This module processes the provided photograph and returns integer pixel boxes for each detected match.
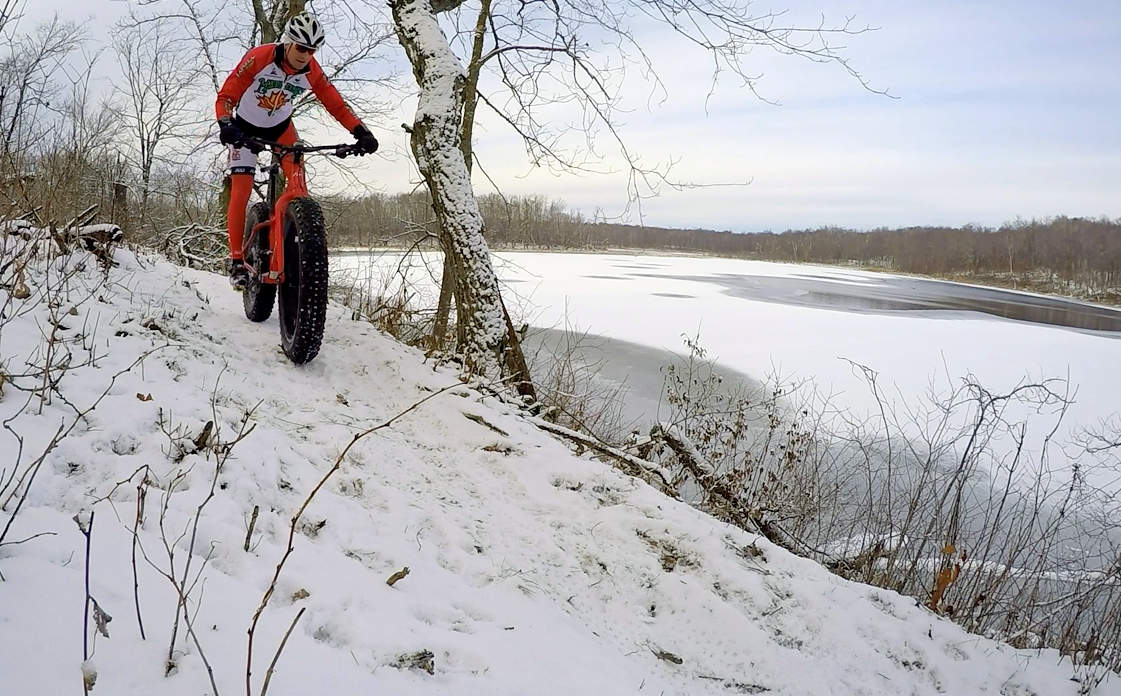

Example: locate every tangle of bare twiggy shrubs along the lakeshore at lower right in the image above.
[643,333,1121,684]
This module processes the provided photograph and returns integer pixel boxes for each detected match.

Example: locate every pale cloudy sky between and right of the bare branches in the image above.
[17,0,1121,231]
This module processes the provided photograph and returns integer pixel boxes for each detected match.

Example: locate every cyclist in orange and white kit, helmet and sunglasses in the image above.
[214,12,378,290]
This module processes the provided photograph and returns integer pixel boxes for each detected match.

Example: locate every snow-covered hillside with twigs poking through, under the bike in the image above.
[0,242,1103,696]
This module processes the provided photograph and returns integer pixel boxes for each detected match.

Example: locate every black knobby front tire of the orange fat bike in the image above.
[279,198,327,365]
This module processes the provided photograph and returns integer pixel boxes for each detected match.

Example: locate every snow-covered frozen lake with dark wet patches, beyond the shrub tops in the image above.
[333,252,1121,450]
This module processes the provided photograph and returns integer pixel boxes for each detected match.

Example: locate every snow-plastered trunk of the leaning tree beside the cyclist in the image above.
[390,0,506,377]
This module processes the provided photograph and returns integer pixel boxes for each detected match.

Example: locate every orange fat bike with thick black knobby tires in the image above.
[241,138,367,364]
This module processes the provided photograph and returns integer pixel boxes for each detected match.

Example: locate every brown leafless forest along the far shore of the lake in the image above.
[327,195,1121,304]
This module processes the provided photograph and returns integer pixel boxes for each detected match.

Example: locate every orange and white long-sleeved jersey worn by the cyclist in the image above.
[214,44,362,140]
